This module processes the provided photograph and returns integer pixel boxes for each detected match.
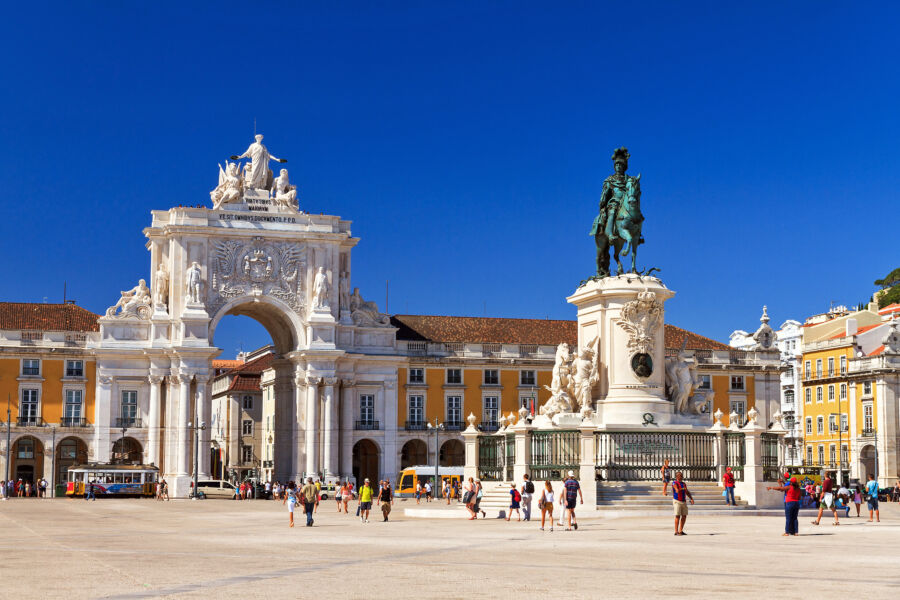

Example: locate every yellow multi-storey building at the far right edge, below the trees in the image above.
[800,309,900,485]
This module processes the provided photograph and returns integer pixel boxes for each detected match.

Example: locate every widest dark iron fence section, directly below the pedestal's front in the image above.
[594,432,717,481]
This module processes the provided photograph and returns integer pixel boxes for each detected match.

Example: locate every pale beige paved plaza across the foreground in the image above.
[0,499,900,600]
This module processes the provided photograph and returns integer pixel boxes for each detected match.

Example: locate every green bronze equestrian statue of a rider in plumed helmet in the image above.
[590,147,644,277]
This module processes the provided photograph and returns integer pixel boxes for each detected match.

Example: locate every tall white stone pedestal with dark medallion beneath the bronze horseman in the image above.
[567,274,681,427]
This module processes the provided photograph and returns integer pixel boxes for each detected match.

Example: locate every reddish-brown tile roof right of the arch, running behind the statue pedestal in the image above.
[391,315,733,350]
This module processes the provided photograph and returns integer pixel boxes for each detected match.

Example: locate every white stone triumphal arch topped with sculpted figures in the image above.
[92,135,400,496]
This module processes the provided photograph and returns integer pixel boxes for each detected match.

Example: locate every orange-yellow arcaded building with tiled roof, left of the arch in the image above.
[0,302,99,494]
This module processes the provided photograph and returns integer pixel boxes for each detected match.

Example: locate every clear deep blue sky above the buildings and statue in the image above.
[0,2,900,355]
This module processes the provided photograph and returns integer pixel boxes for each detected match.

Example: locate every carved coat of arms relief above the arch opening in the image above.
[210,237,306,314]
